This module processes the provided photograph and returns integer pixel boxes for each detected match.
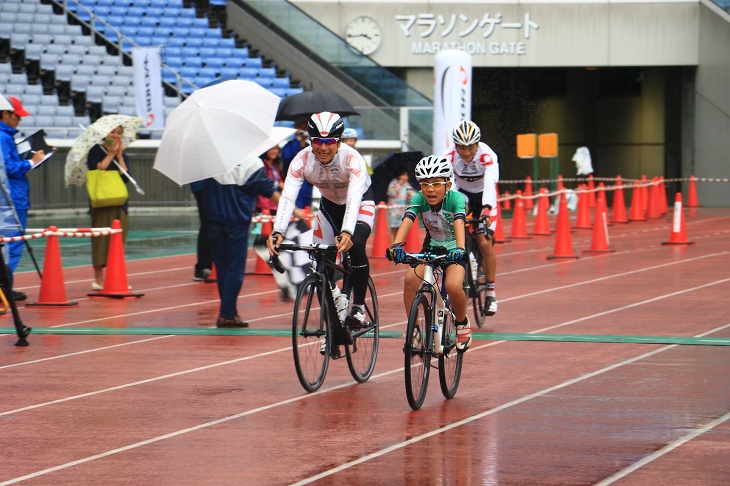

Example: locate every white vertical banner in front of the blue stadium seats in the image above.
[132,47,165,128]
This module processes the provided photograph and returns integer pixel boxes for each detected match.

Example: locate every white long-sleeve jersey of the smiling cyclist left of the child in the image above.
[274,143,370,234]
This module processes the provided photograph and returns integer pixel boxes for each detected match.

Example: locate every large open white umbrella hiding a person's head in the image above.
[153,80,293,185]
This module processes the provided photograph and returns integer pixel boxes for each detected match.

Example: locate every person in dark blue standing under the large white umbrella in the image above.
[203,155,279,327]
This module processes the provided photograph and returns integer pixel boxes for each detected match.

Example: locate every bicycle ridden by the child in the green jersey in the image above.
[392,253,463,410]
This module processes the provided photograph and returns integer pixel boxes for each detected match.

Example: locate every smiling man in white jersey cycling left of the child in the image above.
[267,111,375,323]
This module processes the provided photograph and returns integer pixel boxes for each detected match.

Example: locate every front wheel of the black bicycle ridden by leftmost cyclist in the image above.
[292,274,331,393]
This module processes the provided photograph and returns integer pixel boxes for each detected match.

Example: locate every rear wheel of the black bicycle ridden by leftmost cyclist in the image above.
[345,278,380,383]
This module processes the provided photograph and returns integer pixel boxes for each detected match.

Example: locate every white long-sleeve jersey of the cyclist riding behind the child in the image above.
[444,142,499,208]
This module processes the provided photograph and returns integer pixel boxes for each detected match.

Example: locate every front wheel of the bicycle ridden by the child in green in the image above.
[403,293,433,410]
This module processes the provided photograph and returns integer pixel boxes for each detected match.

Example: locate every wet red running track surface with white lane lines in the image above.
[0,209,730,485]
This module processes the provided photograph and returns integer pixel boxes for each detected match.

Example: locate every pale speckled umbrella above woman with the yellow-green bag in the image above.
[65,115,144,187]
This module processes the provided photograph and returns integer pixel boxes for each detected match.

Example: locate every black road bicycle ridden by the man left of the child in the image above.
[272,243,380,393]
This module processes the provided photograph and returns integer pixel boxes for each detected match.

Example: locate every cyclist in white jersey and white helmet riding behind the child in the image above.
[444,120,501,316]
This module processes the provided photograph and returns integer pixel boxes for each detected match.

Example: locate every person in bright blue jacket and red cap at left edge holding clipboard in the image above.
[0,96,45,300]
